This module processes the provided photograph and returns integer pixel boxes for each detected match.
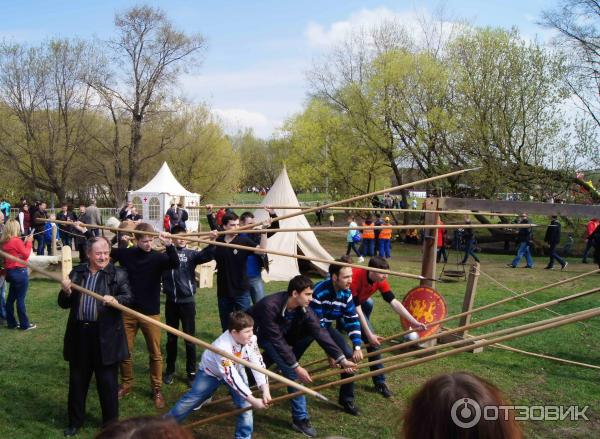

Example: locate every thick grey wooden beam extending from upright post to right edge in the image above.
[438,198,600,218]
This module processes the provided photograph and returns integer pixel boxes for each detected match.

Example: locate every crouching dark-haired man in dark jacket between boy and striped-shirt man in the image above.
[249,275,356,437]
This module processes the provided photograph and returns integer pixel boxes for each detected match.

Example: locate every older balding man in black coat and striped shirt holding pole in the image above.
[58,237,132,436]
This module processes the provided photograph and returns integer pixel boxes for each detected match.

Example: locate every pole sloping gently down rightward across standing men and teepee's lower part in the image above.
[39,219,425,280]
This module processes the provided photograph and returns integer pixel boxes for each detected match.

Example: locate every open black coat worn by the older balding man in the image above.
[58,264,133,365]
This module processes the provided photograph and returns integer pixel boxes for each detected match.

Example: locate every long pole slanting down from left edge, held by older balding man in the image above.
[0,250,327,401]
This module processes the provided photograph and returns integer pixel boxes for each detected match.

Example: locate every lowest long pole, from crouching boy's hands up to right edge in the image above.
[185,308,600,428]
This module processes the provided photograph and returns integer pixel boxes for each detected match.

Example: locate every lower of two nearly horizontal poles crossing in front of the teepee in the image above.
[190,224,540,237]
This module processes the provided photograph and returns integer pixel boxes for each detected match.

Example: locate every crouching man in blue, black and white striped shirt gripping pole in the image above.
[299,261,363,416]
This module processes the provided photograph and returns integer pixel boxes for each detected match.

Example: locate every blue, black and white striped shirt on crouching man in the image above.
[310,279,362,346]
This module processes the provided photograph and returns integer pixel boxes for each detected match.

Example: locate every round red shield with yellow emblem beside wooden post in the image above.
[400,287,448,338]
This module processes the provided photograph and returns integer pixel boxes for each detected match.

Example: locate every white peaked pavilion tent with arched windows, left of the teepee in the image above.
[127,162,200,230]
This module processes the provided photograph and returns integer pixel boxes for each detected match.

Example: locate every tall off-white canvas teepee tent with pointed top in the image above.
[254,168,333,281]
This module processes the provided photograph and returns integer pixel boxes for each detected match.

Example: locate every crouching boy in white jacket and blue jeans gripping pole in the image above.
[165,311,271,439]
